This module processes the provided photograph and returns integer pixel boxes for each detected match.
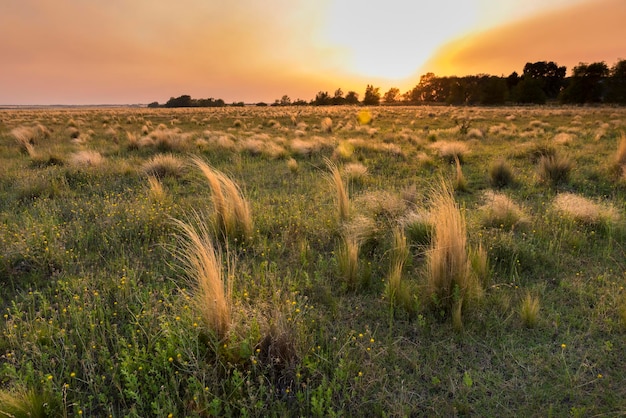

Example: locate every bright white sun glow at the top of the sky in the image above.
[326,0,478,80]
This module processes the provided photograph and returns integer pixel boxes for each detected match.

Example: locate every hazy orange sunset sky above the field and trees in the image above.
[0,0,626,105]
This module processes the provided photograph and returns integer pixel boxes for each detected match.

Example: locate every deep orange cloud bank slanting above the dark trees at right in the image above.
[422,0,626,76]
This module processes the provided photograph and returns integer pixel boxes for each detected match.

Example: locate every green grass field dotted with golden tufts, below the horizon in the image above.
[0,107,626,417]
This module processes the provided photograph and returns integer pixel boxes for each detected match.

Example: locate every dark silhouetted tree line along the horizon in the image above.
[148,60,626,107]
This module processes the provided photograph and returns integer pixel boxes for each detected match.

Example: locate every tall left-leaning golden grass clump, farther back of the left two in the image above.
[191,157,252,240]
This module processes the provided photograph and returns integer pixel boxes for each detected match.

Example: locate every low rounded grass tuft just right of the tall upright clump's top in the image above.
[479,190,529,229]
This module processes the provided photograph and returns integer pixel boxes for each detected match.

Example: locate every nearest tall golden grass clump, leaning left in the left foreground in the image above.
[174,214,232,341]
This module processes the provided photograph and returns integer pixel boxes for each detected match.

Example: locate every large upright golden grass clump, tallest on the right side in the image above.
[426,181,482,328]
